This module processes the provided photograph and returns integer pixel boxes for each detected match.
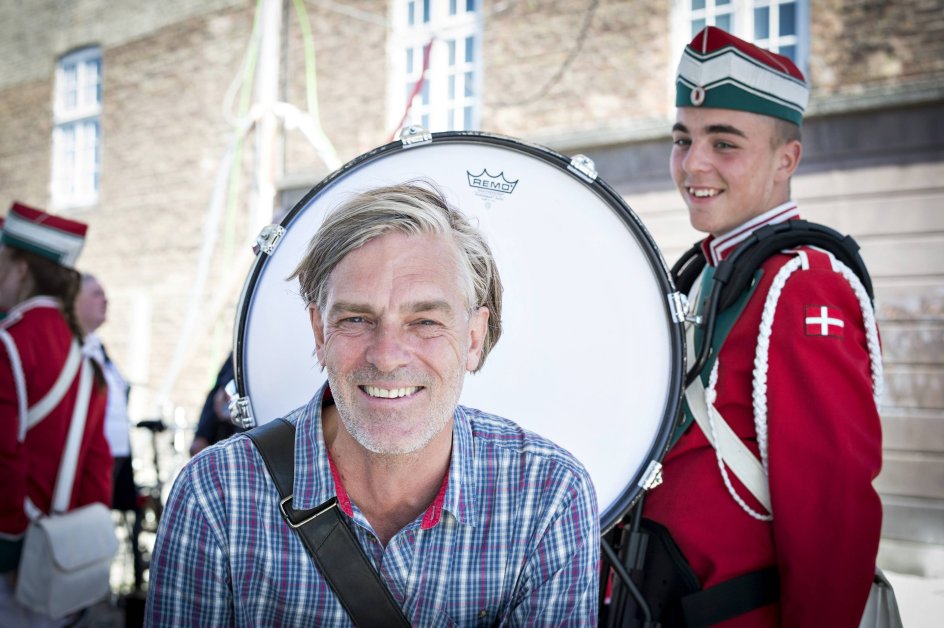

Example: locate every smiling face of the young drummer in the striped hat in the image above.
[672,107,800,236]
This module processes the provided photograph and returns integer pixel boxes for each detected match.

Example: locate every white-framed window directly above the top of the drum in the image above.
[390,0,482,131]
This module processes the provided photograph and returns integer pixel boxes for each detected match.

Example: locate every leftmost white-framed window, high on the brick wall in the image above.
[51,48,102,208]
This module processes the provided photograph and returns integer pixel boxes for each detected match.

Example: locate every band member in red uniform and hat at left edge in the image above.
[0,203,112,626]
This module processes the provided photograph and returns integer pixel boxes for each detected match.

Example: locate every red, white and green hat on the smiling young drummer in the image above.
[675,26,810,126]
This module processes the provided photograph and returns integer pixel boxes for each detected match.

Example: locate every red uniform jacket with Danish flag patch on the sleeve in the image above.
[644,243,882,628]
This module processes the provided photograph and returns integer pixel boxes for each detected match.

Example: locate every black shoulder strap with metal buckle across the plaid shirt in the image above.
[246,419,410,628]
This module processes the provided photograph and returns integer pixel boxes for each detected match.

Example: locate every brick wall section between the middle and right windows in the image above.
[482,0,674,136]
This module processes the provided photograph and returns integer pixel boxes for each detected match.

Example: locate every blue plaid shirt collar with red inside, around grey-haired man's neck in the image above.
[292,382,475,529]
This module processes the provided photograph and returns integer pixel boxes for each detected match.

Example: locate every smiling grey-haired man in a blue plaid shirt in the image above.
[147,184,599,626]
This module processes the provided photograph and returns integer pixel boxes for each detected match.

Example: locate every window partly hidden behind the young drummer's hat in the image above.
[676,0,809,73]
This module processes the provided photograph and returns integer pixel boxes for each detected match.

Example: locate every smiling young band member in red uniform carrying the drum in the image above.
[644,27,882,627]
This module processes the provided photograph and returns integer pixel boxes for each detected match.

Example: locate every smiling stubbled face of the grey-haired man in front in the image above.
[309,233,488,455]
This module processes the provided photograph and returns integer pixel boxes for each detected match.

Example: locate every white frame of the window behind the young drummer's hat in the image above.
[672,0,810,75]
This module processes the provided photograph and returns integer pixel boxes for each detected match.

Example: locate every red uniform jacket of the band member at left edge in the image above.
[0,297,112,560]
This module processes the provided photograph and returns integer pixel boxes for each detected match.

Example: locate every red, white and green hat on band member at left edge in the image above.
[0,202,88,268]
